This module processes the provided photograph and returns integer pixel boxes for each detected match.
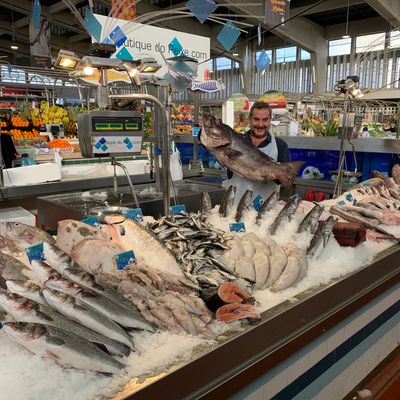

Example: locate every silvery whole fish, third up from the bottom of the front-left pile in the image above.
[43,288,133,349]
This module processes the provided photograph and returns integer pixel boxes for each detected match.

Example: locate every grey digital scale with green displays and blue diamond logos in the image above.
[78,110,143,158]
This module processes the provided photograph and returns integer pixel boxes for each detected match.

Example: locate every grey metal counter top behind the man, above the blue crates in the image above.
[280,136,400,153]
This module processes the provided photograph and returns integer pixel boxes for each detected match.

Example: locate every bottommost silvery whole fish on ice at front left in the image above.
[4,322,123,374]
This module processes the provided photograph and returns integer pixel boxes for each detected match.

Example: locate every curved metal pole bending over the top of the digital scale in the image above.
[110,93,171,215]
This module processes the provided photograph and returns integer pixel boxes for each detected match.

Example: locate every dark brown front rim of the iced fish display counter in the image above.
[121,245,400,400]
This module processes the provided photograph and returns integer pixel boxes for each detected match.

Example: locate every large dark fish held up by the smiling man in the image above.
[200,114,304,186]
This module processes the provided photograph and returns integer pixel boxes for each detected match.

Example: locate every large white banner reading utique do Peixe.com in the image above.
[95,14,210,81]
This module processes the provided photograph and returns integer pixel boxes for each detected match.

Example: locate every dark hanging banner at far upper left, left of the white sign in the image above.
[29,18,51,67]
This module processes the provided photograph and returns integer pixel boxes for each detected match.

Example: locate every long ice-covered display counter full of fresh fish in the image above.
[0,173,400,400]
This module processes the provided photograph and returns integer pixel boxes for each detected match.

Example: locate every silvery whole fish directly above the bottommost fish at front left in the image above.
[0,292,130,356]
